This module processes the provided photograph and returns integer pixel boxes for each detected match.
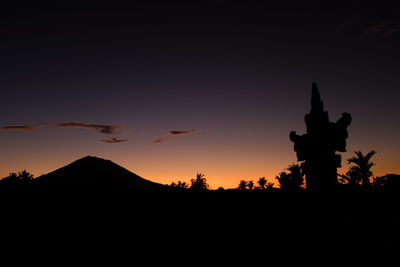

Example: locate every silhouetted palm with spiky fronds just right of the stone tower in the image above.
[340,150,376,186]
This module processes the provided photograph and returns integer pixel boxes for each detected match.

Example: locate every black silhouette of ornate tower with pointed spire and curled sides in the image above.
[289,83,351,191]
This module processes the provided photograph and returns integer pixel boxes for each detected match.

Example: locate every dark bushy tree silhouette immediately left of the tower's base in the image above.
[275,164,304,191]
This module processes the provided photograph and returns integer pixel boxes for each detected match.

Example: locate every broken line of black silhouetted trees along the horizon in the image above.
[0,150,400,192]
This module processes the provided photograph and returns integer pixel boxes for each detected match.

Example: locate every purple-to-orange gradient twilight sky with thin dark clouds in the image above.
[0,0,400,188]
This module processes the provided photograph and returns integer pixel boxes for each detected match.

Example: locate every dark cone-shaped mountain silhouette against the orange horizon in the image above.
[34,156,167,191]
